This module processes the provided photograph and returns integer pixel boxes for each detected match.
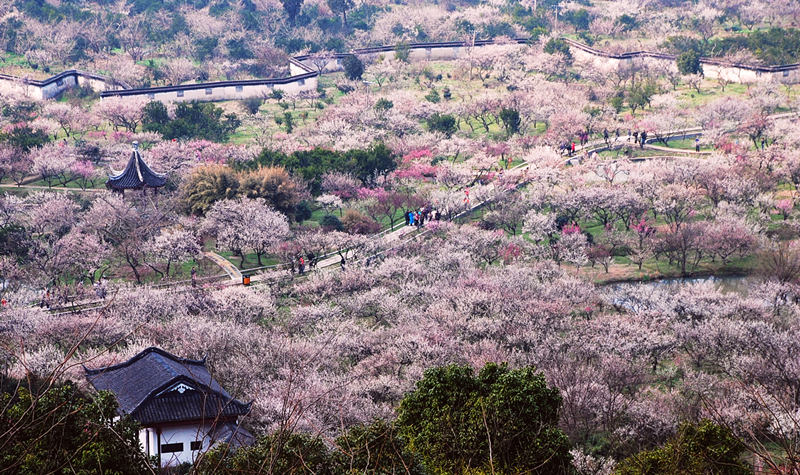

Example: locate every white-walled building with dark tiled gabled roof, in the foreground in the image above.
[83,347,253,467]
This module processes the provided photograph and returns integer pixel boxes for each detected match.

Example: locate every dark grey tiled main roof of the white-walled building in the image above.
[84,348,250,425]
